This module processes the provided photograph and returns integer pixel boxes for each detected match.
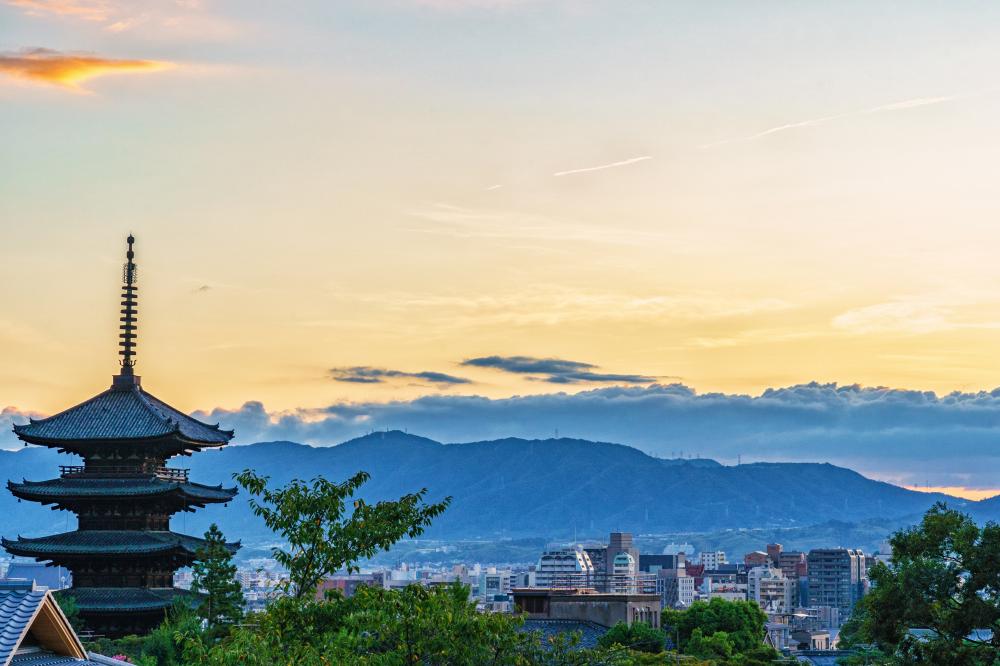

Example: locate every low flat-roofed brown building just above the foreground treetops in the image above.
[514,587,660,628]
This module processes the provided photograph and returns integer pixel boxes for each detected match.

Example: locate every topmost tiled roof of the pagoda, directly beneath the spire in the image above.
[14,385,233,446]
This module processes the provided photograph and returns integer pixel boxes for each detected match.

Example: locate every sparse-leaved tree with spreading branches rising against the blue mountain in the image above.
[234,469,451,598]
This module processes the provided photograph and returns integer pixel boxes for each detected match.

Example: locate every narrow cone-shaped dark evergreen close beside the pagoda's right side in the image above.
[191,523,243,628]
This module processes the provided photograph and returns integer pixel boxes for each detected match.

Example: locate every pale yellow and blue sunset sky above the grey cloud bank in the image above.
[0,0,1000,487]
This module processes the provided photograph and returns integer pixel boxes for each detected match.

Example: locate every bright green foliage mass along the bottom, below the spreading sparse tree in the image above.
[182,583,694,666]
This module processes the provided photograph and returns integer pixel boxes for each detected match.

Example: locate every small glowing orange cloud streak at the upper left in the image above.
[0,49,173,90]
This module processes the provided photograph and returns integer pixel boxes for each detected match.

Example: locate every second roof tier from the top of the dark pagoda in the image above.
[7,477,236,502]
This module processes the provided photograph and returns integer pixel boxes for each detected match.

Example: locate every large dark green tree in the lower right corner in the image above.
[847,503,1000,666]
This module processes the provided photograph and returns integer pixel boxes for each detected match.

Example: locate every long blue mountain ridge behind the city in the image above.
[0,431,968,547]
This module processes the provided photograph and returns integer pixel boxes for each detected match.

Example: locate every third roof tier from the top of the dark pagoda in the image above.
[2,530,239,558]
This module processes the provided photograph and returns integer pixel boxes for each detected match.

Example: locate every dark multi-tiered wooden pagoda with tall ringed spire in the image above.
[2,236,239,636]
